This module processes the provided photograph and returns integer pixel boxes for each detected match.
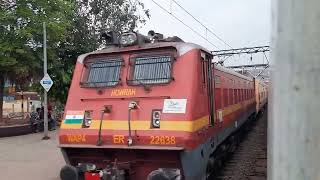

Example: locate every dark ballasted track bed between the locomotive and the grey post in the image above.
[212,110,267,180]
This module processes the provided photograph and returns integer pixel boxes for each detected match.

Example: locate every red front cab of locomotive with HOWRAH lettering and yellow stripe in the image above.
[59,31,214,180]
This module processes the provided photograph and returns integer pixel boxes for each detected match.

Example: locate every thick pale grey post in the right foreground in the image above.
[268,0,320,180]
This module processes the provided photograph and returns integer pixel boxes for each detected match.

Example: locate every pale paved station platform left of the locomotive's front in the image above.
[0,131,65,180]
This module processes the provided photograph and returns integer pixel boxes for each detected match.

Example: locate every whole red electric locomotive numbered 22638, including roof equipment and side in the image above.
[59,32,256,180]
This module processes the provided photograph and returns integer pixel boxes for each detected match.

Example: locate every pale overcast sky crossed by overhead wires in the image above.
[140,0,271,64]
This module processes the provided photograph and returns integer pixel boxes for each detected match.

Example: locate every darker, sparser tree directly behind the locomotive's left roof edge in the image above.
[49,0,149,103]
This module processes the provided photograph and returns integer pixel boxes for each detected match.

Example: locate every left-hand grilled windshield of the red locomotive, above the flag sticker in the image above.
[82,59,123,87]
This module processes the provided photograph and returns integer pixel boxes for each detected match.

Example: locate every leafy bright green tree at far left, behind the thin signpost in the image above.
[0,0,75,120]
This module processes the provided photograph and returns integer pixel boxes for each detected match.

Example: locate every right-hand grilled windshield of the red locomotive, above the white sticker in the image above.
[129,56,172,85]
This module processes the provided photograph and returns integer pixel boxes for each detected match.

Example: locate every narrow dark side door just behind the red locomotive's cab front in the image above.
[201,53,214,126]
